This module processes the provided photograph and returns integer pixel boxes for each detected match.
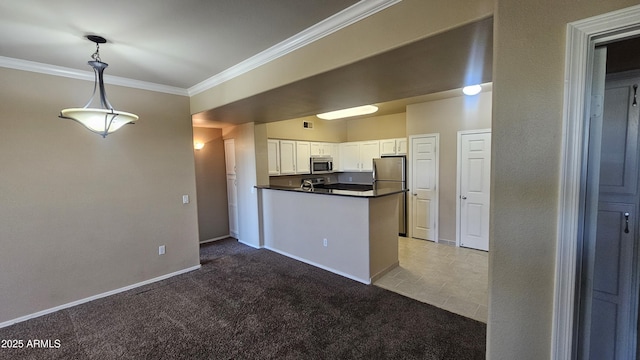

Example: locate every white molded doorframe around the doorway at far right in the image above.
[550,5,640,359]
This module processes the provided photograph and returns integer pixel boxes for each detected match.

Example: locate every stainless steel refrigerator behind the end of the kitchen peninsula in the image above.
[373,156,407,235]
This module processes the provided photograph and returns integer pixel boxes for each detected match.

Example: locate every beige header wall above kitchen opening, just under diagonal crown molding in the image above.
[191,0,494,114]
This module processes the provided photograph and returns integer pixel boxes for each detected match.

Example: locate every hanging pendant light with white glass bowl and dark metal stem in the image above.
[59,35,138,138]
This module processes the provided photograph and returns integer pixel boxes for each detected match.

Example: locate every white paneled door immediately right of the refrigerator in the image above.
[410,134,440,242]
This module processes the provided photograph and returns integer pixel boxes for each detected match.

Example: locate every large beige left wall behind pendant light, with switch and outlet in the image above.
[0,68,199,323]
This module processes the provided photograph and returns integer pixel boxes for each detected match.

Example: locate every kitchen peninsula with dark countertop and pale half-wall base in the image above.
[258,186,406,284]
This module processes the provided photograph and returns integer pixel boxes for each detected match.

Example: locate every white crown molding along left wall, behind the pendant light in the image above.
[0,56,189,96]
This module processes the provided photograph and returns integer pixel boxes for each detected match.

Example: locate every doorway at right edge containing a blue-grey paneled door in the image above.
[575,38,640,359]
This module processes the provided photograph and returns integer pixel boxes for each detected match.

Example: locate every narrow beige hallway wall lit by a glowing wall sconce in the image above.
[193,127,229,241]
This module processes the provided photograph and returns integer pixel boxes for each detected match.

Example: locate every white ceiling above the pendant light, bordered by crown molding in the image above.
[0,0,390,93]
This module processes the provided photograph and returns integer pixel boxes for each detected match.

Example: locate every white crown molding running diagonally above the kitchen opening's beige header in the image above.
[188,0,402,96]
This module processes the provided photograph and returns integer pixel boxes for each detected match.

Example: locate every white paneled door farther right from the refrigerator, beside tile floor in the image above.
[456,130,491,251]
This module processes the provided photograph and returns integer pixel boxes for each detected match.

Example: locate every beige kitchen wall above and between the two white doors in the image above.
[407,91,491,244]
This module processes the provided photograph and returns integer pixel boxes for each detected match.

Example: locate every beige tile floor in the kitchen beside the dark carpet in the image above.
[374,237,489,323]
